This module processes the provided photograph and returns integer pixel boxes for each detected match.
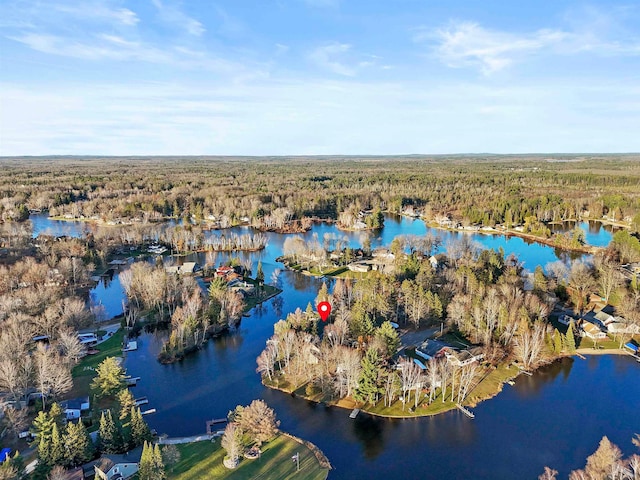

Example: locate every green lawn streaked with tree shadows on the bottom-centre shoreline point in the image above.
[167,435,328,480]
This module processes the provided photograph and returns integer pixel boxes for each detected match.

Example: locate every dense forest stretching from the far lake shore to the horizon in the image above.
[0,155,640,233]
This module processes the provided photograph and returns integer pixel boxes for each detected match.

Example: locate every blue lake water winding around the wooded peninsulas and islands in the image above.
[25,217,640,480]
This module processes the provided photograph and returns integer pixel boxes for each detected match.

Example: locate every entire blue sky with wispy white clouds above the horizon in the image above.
[0,0,640,155]
